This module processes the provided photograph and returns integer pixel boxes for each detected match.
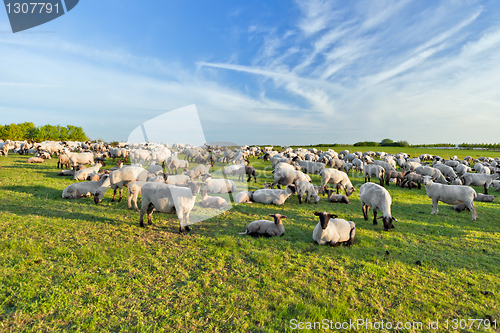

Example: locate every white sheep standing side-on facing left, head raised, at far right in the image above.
[424,176,477,221]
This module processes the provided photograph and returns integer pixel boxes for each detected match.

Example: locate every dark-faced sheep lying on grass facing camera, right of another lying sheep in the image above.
[312,212,356,246]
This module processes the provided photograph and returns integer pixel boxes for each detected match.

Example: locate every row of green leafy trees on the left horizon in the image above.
[0,122,88,142]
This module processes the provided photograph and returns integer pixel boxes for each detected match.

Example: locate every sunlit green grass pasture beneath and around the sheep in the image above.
[0,147,500,332]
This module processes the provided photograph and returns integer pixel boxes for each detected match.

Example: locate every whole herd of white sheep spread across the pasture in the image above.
[0,140,500,245]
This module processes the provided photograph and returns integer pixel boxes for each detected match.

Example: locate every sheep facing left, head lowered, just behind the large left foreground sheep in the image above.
[94,166,148,204]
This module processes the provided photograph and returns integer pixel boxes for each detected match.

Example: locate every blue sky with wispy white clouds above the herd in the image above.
[0,0,500,145]
